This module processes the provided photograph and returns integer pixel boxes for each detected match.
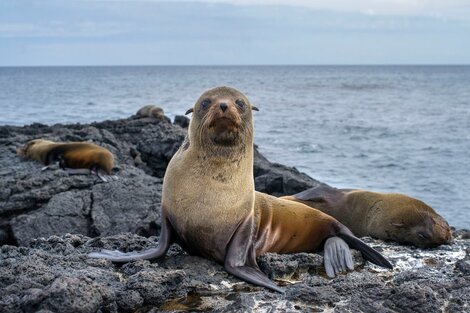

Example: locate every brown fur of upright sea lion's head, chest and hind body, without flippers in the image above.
[162,87,366,262]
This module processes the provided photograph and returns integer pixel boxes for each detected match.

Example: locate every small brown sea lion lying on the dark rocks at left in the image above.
[17,139,114,181]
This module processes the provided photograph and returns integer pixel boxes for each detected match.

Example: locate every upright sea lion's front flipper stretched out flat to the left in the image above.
[88,216,173,263]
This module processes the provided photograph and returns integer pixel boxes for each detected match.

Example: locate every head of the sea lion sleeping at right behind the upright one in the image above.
[377,194,452,248]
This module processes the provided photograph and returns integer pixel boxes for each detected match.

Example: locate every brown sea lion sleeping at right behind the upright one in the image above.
[282,185,452,247]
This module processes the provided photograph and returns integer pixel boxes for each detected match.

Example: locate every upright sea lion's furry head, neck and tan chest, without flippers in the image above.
[162,87,254,262]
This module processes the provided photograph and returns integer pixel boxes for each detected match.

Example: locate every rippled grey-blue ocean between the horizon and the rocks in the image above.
[0,66,470,228]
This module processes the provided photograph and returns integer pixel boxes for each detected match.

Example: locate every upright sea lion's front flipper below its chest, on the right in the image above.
[224,217,284,293]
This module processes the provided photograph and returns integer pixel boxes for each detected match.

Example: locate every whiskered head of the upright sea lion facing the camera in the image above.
[186,87,258,153]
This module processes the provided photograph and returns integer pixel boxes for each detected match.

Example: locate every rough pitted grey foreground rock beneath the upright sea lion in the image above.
[0,228,470,313]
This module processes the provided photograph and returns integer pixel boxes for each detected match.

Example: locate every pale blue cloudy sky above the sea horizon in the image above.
[0,0,470,66]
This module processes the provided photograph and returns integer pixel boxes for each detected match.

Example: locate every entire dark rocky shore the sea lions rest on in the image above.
[0,117,470,313]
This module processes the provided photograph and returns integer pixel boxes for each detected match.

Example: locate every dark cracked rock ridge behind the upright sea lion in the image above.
[0,117,319,245]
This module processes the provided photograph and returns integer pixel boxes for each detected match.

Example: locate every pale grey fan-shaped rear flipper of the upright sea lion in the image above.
[323,237,354,278]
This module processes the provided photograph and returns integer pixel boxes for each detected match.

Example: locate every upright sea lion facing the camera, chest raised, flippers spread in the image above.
[89,87,392,292]
